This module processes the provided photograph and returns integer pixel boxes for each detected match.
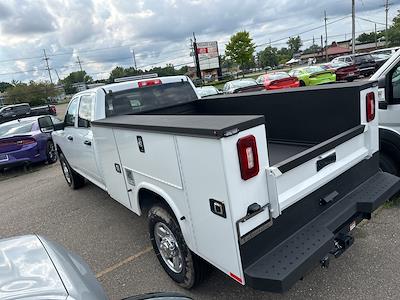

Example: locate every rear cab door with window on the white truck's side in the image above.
[74,94,103,184]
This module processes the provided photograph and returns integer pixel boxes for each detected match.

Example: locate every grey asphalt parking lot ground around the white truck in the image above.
[0,163,400,299]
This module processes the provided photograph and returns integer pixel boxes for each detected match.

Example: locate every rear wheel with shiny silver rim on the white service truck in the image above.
[148,206,208,289]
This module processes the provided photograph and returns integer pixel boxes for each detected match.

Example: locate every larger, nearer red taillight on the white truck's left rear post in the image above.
[237,135,260,180]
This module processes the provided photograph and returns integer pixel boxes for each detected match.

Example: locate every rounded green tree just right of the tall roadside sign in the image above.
[225,31,255,70]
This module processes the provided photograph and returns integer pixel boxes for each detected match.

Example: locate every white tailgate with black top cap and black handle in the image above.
[267,87,379,217]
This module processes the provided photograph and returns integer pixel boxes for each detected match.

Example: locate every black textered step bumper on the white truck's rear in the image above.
[241,155,400,292]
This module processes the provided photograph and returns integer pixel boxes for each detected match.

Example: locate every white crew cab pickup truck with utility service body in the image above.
[49,76,400,292]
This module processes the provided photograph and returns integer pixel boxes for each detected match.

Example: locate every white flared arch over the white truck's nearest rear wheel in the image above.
[132,182,193,251]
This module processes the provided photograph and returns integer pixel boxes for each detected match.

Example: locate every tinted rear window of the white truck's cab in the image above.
[106,81,197,117]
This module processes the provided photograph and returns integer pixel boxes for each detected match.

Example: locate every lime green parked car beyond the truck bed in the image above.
[289,66,336,86]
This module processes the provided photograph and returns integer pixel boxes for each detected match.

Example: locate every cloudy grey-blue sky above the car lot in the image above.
[0,0,400,82]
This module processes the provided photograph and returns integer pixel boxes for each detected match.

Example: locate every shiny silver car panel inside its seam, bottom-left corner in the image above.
[0,235,68,300]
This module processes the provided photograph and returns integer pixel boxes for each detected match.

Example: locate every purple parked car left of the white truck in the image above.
[0,116,60,169]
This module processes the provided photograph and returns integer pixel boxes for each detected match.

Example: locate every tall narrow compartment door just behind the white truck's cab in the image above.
[93,126,132,209]
